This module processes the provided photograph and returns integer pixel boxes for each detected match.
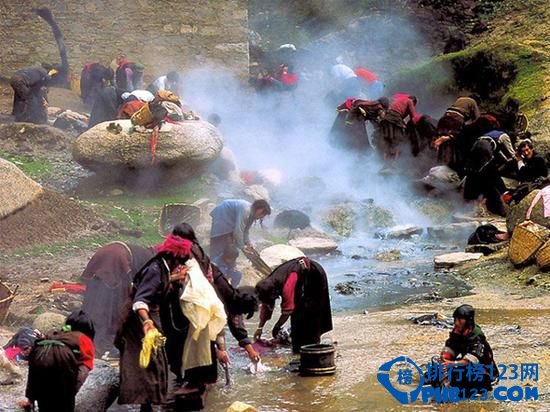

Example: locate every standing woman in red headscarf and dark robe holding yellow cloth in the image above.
[115,233,192,412]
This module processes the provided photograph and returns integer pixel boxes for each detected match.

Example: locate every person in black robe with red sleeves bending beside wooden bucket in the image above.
[254,257,332,353]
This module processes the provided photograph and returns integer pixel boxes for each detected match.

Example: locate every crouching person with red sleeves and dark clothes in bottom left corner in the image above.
[26,310,95,412]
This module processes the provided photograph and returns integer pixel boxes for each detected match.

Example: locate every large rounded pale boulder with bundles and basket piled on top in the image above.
[73,120,223,174]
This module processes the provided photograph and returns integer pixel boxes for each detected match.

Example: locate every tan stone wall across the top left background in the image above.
[0,0,248,80]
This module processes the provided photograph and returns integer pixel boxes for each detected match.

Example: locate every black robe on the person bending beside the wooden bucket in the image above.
[256,258,332,353]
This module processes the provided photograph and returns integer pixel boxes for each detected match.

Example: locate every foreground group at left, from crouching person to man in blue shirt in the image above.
[2,199,332,412]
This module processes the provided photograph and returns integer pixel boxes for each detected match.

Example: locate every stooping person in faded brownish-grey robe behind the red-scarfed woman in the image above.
[81,242,155,354]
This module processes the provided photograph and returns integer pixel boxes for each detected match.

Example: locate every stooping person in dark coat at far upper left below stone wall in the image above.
[10,66,50,124]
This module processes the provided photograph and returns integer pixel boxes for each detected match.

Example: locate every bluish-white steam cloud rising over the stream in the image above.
[180,12,460,230]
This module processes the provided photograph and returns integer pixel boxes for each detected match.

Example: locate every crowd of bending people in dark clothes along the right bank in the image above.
[331,94,548,216]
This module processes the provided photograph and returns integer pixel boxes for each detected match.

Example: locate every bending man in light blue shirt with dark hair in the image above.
[210,199,271,286]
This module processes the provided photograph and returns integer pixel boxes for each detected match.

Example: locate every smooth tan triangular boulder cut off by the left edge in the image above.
[0,159,44,219]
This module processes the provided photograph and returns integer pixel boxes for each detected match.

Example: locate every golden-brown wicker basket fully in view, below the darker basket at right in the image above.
[508,221,550,265]
